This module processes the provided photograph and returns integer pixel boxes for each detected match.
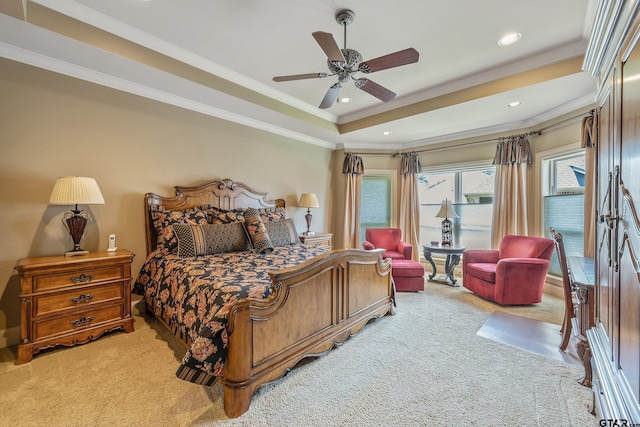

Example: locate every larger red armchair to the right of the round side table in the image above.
[462,235,555,305]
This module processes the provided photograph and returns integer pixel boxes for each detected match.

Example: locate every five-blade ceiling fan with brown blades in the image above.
[273,9,419,109]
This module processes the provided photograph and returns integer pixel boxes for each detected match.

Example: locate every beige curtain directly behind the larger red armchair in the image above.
[491,135,531,248]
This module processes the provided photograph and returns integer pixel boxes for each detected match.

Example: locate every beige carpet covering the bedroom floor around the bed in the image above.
[0,283,597,426]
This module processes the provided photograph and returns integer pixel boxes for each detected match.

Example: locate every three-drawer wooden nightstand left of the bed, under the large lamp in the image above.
[15,250,135,364]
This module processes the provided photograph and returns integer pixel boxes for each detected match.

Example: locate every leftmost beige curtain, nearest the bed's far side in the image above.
[342,153,364,248]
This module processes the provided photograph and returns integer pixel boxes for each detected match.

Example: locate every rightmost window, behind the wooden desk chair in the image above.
[542,150,585,275]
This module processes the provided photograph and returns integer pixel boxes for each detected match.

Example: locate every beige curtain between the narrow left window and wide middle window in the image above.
[400,151,422,261]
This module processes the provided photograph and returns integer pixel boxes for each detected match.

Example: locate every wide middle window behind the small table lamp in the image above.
[418,163,495,249]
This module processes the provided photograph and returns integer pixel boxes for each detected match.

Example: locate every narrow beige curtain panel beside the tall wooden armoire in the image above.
[582,112,598,258]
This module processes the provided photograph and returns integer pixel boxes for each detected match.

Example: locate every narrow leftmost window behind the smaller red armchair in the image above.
[360,171,395,242]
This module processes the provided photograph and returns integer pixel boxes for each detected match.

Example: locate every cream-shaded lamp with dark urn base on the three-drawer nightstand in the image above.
[49,176,104,256]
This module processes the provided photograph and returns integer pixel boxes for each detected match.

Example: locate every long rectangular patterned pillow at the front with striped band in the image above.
[172,222,250,257]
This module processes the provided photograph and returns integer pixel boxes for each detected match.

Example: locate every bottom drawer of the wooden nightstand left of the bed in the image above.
[34,304,124,340]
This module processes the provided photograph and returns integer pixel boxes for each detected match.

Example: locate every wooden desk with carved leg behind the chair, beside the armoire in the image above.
[567,256,595,387]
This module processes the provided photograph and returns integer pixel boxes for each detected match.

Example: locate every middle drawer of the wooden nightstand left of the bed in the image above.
[33,282,124,316]
